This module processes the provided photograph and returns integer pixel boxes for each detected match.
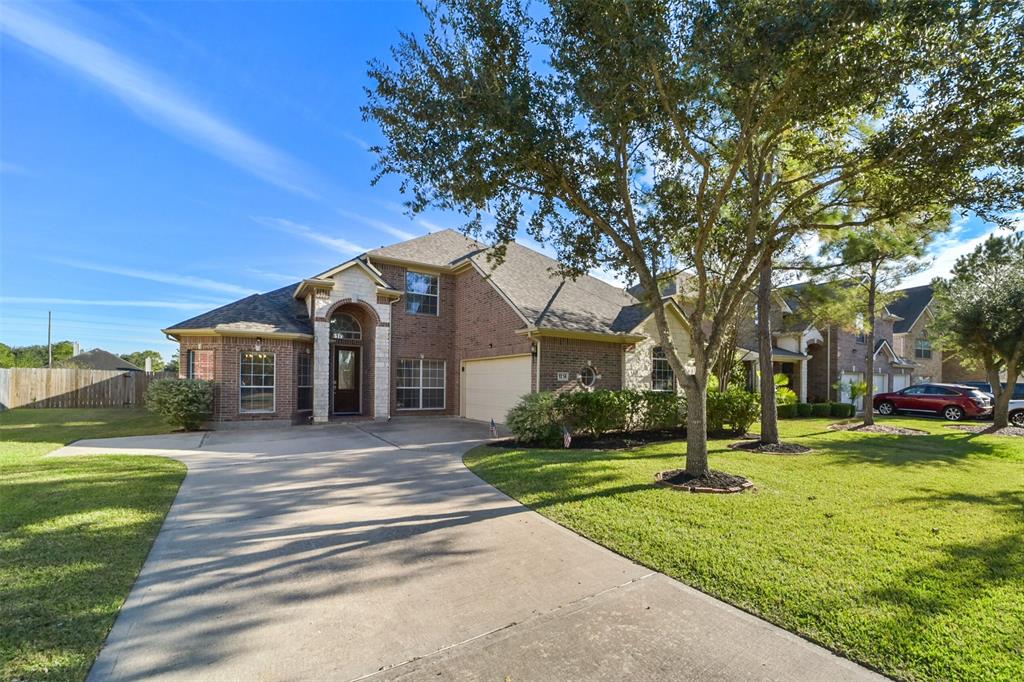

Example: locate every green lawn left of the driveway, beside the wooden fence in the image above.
[0,409,185,680]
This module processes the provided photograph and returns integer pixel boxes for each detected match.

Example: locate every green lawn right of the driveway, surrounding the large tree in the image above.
[466,419,1024,680]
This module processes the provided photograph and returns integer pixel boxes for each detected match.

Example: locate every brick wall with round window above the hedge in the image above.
[540,337,623,391]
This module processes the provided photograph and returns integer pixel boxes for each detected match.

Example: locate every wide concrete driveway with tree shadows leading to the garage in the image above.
[57,419,879,680]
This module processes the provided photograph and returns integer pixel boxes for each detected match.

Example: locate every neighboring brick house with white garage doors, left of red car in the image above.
[739,285,915,408]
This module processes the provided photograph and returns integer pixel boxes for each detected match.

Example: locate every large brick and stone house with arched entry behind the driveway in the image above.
[164,230,687,422]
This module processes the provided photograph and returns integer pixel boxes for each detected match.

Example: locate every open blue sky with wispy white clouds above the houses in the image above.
[0,1,1015,357]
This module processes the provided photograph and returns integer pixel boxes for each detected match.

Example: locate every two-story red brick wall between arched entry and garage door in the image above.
[380,264,459,415]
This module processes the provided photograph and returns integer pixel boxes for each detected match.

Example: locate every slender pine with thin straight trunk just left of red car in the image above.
[821,204,949,425]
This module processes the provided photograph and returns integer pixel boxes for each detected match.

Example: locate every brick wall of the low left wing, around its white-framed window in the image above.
[179,336,312,421]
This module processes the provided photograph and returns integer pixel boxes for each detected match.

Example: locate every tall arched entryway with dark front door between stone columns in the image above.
[328,302,377,417]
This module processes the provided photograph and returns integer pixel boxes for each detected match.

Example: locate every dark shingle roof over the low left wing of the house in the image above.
[168,283,313,334]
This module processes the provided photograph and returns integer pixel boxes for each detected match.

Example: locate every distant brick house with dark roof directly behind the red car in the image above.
[888,285,948,384]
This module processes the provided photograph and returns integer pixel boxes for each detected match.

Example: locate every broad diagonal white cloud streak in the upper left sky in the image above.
[0,3,316,198]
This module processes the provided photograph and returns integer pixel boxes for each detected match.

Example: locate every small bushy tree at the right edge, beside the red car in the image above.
[934,232,1024,428]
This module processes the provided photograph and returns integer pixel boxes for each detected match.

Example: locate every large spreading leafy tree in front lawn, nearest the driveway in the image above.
[364,0,1024,477]
